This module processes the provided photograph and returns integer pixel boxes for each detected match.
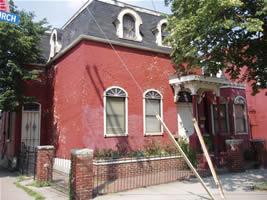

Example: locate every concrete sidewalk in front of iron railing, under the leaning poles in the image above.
[95,170,267,200]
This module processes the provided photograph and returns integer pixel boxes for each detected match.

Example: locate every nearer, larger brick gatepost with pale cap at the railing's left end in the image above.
[70,149,93,200]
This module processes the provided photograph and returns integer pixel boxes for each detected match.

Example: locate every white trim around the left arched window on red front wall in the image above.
[104,86,128,137]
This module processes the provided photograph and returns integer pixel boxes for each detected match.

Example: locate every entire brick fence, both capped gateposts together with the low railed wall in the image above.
[36,146,207,200]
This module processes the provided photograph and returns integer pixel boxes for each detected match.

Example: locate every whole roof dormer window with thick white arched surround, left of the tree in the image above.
[116,8,143,42]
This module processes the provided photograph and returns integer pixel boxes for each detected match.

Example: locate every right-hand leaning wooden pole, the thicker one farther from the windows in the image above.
[192,118,226,199]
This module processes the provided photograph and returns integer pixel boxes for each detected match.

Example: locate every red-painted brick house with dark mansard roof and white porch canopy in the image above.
[1,0,267,165]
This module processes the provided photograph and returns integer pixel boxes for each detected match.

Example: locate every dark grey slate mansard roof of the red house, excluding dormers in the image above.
[38,0,170,62]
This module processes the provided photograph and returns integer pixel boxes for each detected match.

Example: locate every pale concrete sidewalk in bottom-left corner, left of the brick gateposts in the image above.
[0,168,34,200]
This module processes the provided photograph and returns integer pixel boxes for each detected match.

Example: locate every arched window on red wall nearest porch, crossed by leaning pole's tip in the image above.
[144,90,163,135]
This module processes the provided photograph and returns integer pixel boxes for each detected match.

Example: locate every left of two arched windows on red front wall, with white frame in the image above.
[104,87,128,137]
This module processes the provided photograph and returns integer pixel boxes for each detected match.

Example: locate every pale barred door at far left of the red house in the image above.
[21,103,41,150]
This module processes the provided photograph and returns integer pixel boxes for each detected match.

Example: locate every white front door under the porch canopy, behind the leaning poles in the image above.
[177,102,194,139]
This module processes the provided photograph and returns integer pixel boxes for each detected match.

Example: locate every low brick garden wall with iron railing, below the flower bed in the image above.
[94,156,192,195]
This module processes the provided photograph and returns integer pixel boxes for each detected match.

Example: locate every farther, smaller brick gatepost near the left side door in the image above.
[36,146,55,182]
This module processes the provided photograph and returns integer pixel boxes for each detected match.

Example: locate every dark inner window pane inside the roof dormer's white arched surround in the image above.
[123,14,136,39]
